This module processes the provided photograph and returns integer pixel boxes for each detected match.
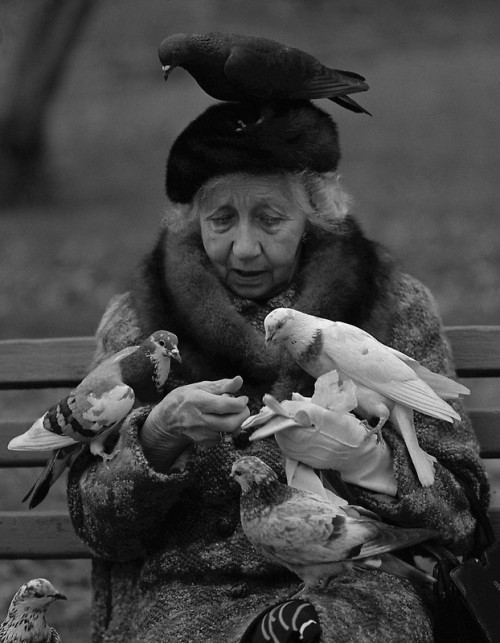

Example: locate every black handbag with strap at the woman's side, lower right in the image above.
[421,471,500,643]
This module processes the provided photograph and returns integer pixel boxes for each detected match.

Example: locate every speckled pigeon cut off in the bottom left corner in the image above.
[0,578,66,643]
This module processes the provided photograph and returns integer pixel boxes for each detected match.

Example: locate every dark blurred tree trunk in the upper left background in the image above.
[0,0,95,205]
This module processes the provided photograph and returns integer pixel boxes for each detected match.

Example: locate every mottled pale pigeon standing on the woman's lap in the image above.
[231,456,437,591]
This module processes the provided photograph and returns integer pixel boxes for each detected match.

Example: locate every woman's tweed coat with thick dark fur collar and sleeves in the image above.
[68,219,488,643]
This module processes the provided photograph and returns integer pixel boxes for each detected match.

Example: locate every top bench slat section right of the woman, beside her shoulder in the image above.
[446,326,500,377]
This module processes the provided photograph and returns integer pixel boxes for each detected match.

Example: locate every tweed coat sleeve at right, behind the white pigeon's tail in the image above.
[346,275,489,552]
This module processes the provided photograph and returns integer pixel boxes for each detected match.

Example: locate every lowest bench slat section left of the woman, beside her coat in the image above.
[0,511,92,559]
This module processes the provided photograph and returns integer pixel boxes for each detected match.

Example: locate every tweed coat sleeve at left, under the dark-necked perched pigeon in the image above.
[68,295,197,561]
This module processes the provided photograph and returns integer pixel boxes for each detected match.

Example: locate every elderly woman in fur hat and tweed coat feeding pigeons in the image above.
[68,101,487,643]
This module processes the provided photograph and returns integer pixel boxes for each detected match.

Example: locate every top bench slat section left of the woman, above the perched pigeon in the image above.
[0,337,95,389]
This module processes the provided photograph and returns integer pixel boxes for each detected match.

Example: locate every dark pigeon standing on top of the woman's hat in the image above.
[158,33,369,114]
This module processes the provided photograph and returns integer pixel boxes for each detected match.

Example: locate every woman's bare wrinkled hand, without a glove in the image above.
[140,375,250,472]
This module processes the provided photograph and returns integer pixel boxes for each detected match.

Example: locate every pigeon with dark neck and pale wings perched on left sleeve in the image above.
[8,330,181,509]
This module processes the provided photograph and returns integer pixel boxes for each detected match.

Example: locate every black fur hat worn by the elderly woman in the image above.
[166,101,340,203]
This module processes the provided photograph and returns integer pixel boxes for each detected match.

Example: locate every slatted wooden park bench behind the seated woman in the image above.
[0,326,500,559]
